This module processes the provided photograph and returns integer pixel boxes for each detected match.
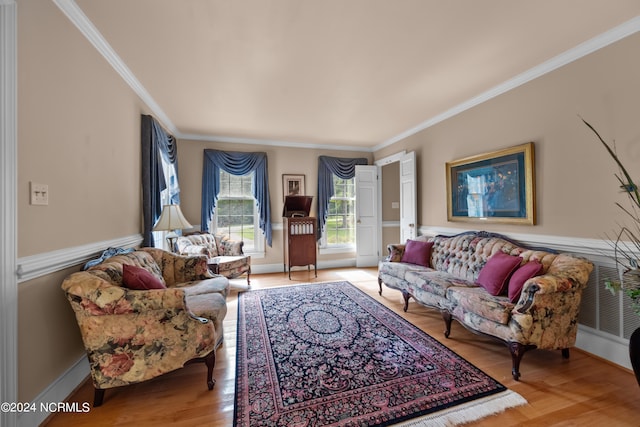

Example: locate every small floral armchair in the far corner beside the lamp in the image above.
[176,233,251,284]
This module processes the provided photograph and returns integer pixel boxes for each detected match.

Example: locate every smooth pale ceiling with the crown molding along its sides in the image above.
[54,0,640,151]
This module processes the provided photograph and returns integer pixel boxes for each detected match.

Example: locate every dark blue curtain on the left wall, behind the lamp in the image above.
[141,115,180,246]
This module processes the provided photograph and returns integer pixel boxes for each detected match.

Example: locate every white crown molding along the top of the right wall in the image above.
[373,16,640,152]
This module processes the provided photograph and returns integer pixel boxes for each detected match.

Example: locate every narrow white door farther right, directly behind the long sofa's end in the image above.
[400,151,418,243]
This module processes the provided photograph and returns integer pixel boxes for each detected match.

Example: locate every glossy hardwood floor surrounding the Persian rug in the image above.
[44,268,640,427]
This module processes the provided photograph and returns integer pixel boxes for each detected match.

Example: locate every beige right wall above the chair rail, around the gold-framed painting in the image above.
[375,34,640,238]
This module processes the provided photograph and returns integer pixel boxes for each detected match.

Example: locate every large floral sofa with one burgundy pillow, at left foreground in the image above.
[62,248,229,406]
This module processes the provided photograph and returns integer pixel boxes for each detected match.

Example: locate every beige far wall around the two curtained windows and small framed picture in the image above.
[178,140,372,265]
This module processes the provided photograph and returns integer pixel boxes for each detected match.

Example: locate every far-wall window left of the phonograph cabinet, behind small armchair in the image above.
[213,170,264,253]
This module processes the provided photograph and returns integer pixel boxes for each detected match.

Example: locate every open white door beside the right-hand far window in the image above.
[355,166,382,267]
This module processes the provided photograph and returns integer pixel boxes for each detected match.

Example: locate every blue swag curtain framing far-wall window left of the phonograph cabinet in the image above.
[200,149,271,246]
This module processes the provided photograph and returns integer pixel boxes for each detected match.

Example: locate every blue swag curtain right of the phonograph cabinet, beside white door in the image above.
[318,156,367,240]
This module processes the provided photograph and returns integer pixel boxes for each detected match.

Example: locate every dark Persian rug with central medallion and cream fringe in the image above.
[234,282,527,427]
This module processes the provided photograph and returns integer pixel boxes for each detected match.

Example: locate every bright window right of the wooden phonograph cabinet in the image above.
[322,175,356,248]
